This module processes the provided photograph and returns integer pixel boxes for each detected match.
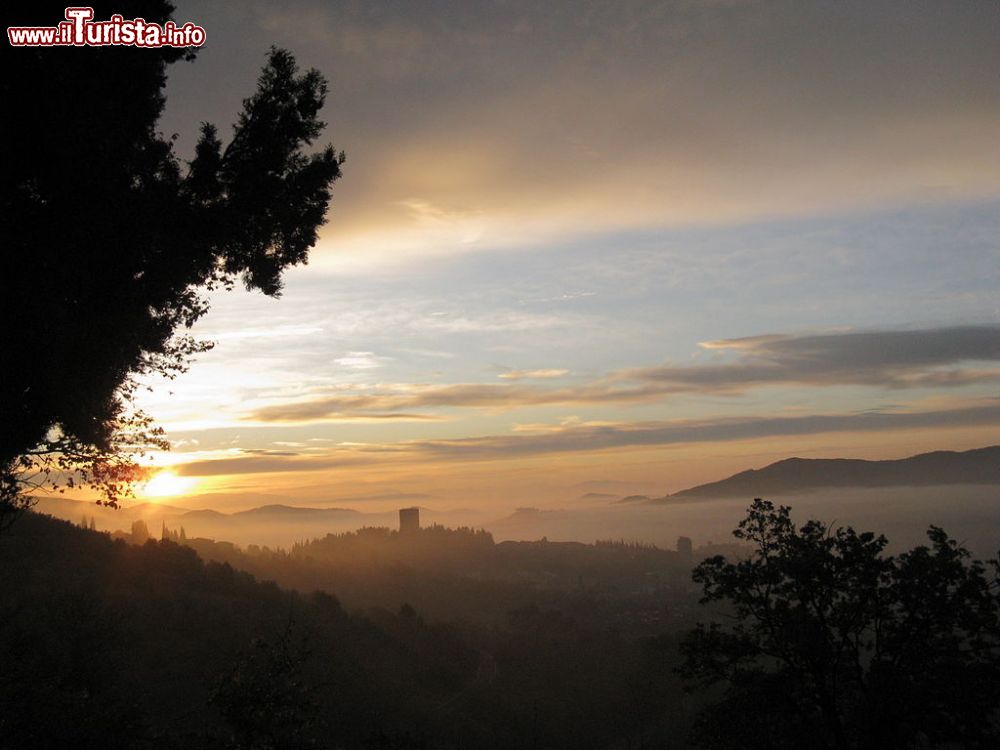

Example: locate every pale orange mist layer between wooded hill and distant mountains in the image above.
[37,485,1000,557]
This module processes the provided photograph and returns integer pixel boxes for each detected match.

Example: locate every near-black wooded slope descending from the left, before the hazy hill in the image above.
[0,514,682,750]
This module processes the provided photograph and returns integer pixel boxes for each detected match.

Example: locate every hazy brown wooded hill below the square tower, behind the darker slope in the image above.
[168,526,697,636]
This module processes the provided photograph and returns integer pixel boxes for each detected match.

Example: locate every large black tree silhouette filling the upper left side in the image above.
[0,0,344,521]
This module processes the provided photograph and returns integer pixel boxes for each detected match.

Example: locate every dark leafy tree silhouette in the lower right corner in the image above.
[682,499,1000,749]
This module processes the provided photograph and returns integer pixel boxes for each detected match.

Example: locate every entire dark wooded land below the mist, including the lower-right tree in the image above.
[0,508,1000,750]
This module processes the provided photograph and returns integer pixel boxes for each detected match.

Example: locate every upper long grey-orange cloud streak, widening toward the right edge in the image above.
[248,326,1000,422]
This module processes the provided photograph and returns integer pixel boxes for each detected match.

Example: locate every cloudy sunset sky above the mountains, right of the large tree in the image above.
[133,0,1000,509]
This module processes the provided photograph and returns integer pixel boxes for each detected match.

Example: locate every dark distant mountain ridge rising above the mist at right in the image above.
[664,445,1000,503]
